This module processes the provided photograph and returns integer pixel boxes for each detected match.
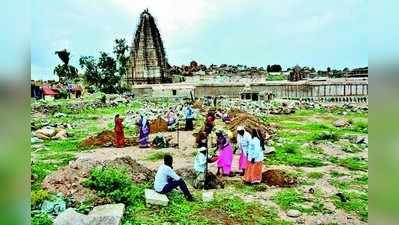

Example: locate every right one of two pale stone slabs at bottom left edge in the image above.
[88,203,125,225]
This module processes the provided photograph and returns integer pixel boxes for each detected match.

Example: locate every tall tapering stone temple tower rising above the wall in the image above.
[125,9,170,85]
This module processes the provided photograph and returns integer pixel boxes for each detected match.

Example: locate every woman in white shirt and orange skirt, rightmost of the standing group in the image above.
[244,129,264,184]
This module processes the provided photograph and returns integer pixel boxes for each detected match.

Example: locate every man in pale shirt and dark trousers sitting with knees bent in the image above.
[154,155,194,201]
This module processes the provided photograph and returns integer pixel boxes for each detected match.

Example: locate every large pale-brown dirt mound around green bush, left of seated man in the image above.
[42,156,155,202]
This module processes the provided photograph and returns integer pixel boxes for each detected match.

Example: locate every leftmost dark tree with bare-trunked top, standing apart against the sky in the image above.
[54,49,79,83]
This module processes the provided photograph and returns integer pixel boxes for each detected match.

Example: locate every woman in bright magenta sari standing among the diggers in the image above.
[216,131,233,176]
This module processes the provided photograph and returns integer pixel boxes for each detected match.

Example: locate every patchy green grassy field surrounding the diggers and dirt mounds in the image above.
[31,96,368,225]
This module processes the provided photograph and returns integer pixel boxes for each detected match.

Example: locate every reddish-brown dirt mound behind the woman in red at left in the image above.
[80,130,137,147]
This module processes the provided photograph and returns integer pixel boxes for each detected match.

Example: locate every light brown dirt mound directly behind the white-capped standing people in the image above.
[227,113,277,140]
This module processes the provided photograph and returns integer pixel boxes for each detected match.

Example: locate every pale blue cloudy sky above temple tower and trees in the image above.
[30,0,369,79]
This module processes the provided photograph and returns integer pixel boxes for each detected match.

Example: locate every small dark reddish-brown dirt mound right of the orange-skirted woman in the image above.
[262,170,297,187]
